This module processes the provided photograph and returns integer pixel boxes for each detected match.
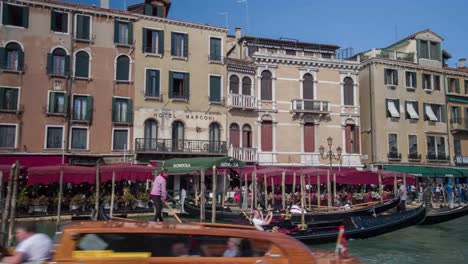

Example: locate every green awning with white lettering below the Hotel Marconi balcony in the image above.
[164,156,245,174]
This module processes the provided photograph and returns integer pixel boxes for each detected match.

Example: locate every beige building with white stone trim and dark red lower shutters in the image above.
[227,29,361,167]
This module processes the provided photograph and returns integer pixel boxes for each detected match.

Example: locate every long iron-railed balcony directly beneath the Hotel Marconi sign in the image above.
[135,138,227,155]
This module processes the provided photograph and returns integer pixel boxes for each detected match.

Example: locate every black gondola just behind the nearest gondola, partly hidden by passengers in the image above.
[184,198,400,222]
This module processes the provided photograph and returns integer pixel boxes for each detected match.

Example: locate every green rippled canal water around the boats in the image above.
[14,216,468,264]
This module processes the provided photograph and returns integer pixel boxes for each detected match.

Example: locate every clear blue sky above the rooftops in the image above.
[66,0,468,66]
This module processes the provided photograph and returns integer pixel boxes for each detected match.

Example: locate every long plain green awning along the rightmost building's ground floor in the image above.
[383,165,468,177]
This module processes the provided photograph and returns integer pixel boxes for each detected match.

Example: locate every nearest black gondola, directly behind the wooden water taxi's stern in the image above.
[286,204,426,244]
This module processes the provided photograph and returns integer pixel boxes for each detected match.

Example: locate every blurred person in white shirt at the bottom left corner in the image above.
[1,222,53,264]
